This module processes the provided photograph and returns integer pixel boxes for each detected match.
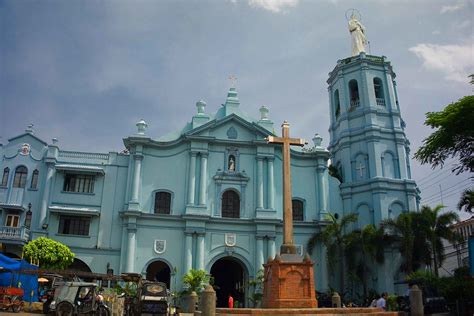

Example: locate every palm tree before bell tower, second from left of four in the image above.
[346,224,393,299]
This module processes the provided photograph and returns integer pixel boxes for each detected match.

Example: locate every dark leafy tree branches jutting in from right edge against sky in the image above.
[415,95,474,174]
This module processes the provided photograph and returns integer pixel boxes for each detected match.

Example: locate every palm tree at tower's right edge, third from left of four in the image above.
[381,213,415,274]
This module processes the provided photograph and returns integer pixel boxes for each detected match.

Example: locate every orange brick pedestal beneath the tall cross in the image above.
[262,254,318,308]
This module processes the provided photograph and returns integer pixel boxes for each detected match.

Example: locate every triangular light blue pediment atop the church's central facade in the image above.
[186,114,273,141]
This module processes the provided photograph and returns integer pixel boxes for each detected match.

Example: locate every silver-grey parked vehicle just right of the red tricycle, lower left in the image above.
[49,282,110,316]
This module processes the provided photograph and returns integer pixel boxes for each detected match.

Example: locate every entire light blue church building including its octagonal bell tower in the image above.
[0,53,418,304]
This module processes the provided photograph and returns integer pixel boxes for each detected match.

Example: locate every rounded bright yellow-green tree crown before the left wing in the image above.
[23,237,75,269]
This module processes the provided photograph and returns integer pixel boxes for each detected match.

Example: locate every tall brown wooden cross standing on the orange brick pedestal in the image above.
[267,121,306,254]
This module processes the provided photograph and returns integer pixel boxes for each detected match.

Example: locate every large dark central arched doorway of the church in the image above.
[211,257,248,307]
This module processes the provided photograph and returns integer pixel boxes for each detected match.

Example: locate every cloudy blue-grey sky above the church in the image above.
[0,0,474,217]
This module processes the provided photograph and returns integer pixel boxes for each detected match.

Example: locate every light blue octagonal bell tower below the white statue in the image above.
[327,51,418,290]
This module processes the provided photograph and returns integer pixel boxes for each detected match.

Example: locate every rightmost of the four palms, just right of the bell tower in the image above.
[417,205,459,276]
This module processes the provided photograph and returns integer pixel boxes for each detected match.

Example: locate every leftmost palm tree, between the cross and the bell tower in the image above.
[307,213,358,293]
